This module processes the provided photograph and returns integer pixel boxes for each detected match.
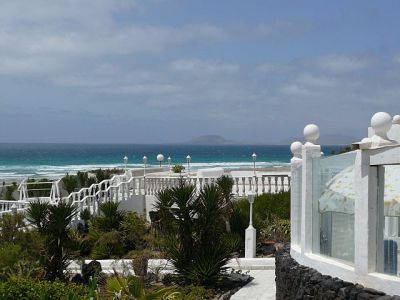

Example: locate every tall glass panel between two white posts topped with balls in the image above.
[313,152,356,263]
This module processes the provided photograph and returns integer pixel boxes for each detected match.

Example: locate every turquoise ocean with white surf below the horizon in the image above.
[0,143,343,181]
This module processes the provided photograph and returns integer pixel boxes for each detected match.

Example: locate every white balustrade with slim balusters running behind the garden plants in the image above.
[0,172,290,218]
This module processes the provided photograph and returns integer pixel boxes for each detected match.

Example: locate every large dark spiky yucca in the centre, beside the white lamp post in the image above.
[157,183,232,285]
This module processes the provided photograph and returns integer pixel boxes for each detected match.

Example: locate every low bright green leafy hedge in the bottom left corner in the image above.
[0,278,89,300]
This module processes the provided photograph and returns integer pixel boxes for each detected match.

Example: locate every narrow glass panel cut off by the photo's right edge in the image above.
[377,165,400,277]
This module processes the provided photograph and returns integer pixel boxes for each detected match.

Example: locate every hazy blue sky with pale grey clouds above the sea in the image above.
[0,0,400,144]
